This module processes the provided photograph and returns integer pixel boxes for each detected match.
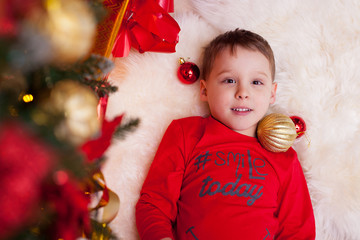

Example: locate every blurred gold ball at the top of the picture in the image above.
[38,0,96,63]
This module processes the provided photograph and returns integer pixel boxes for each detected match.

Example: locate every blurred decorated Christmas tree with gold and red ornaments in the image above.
[0,0,138,240]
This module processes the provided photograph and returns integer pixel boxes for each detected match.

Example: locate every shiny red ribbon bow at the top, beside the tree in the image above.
[112,0,180,57]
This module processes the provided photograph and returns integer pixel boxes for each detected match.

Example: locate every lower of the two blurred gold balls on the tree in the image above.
[48,80,100,145]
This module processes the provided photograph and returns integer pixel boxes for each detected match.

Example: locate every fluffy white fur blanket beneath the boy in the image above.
[104,0,360,240]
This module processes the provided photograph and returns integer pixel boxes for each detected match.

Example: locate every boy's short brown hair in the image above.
[202,28,275,80]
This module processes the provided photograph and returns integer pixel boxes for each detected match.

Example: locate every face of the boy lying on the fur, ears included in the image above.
[200,47,277,137]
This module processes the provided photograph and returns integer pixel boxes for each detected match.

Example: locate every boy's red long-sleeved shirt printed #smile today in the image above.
[136,117,315,240]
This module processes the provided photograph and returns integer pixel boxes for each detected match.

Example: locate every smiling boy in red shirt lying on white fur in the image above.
[136,29,315,240]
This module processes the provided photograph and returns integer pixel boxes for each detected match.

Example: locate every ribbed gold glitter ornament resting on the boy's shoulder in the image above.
[257,113,297,152]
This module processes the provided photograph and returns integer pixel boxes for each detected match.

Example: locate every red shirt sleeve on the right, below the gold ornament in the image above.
[275,154,315,240]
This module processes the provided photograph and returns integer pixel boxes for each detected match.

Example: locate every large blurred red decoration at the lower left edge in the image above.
[0,122,54,238]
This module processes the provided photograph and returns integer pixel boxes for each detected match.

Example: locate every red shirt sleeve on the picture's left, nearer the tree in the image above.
[136,121,185,240]
